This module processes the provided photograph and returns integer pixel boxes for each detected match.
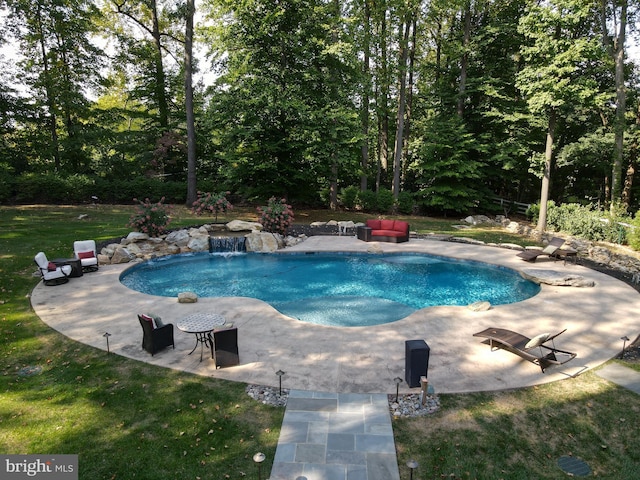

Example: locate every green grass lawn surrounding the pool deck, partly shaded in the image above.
[0,205,640,480]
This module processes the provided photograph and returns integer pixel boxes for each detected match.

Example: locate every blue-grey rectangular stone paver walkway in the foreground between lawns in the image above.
[270,390,400,480]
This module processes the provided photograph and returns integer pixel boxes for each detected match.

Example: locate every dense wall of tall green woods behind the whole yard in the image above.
[0,0,640,221]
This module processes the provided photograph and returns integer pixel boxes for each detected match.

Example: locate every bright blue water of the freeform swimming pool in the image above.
[120,253,540,326]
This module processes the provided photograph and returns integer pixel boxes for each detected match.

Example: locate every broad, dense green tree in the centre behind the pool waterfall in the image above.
[204,0,359,202]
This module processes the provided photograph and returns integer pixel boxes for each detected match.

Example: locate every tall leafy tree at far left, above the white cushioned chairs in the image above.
[6,0,103,171]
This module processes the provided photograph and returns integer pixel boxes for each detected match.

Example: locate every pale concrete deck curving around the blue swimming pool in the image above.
[31,236,640,393]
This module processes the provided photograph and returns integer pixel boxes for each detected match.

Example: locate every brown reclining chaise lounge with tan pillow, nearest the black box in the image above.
[473,328,577,373]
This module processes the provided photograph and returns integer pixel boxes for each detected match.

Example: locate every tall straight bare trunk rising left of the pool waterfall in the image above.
[184,0,197,206]
